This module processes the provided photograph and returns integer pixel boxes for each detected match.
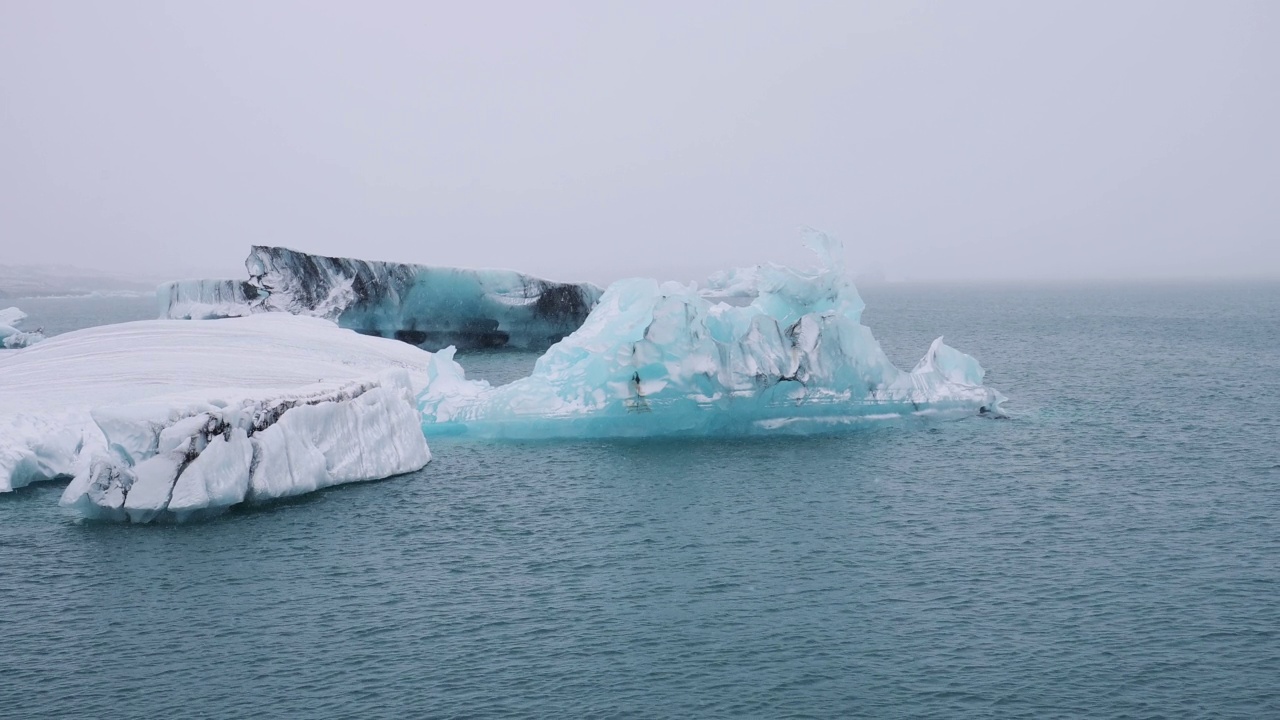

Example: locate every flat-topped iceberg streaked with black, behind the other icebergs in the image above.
[157,246,600,350]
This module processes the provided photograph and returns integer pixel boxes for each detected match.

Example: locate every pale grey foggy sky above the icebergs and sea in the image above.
[0,0,1280,282]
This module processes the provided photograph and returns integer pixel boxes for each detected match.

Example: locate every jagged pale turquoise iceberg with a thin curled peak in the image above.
[419,232,1004,437]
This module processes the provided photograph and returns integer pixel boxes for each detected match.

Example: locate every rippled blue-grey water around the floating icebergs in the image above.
[0,284,1280,717]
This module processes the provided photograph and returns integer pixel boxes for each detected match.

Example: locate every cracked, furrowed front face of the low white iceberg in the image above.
[61,370,431,523]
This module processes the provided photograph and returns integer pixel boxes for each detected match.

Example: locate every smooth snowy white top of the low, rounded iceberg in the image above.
[0,314,430,492]
